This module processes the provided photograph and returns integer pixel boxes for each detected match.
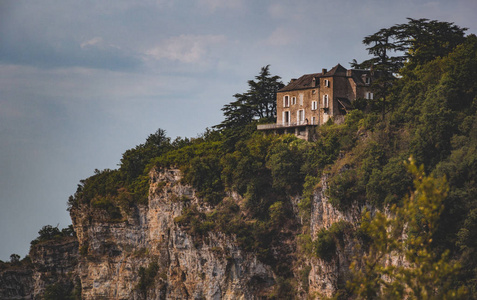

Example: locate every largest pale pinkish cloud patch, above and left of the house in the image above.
[146,35,226,63]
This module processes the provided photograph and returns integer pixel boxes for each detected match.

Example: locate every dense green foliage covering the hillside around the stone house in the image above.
[69,19,477,298]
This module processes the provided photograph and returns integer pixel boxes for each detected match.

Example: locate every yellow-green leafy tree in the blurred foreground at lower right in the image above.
[348,160,465,299]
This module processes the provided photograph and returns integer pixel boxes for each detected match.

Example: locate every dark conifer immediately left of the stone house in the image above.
[214,65,284,129]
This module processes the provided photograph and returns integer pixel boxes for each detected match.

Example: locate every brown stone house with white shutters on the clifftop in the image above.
[257,64,373,140]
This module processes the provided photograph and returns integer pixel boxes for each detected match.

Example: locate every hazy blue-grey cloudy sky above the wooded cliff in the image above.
[0,0,477,261]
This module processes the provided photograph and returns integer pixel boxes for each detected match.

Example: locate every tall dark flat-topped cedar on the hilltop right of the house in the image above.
[351,18,467,119]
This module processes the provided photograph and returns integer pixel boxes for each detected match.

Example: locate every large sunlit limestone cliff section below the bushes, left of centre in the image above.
[72,170,274,299]
